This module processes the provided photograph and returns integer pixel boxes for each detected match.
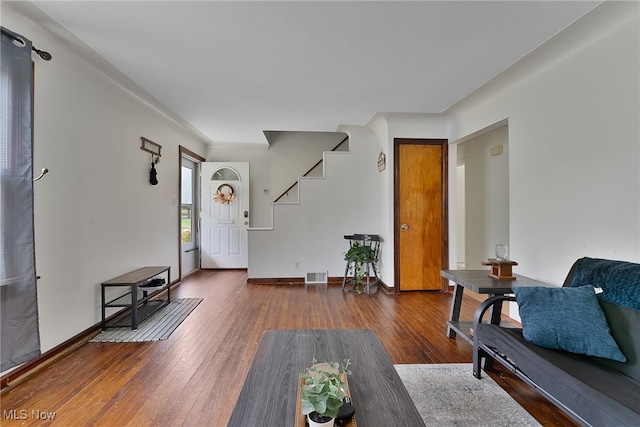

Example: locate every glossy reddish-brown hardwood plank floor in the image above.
[0,271,575,427]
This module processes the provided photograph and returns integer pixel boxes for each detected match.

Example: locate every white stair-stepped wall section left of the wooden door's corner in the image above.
[249,126,385,278]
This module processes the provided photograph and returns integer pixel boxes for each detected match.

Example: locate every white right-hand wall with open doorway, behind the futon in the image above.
[447,2,640,285]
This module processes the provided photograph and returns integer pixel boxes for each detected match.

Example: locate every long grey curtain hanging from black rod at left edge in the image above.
[0,28,40,371]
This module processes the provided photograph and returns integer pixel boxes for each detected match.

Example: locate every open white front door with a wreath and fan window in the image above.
[200,162,249,268]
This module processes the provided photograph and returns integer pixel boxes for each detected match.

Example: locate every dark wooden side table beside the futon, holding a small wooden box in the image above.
[440,270,553,344]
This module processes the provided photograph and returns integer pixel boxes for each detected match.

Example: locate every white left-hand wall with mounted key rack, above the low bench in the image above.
[2,2,205,358]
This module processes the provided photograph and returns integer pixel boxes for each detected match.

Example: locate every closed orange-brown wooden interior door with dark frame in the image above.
[394,139,448,291]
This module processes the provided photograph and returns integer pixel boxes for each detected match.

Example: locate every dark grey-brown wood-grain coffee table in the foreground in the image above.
[228,329,424,427]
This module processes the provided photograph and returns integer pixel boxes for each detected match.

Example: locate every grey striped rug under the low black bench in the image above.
[89,298,202,342]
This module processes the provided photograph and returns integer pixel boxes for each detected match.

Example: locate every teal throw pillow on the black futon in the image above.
[513,286,627,362]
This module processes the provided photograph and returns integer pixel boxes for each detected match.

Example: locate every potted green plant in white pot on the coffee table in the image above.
[300,358,351,427]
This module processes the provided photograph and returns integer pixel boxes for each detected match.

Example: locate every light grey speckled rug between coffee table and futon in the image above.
[395,363,540,427]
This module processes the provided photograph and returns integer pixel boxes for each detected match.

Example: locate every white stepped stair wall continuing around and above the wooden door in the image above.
[249,113,447,286]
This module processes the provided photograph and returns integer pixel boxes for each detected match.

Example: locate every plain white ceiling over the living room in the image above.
[34,1,599,143]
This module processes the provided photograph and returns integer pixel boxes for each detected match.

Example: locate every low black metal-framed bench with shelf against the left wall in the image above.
[101,266,171,331]
